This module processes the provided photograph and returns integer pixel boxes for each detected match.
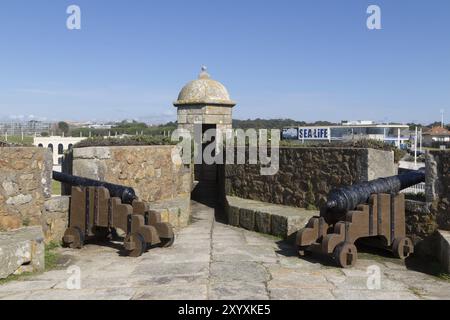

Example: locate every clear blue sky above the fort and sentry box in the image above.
[0,0,450,123]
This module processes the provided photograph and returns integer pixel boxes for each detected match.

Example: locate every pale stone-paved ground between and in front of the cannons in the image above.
[0,202,450,300]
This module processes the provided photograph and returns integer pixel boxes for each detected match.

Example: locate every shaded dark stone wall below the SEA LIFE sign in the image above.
[223,147,397,208]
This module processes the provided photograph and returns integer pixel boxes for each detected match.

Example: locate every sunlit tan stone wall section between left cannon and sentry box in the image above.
[69,145,192,227]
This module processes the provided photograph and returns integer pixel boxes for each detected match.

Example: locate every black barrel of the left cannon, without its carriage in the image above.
[53,171,137,204]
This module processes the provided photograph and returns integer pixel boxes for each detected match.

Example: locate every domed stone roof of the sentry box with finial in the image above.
[174,67,236,107]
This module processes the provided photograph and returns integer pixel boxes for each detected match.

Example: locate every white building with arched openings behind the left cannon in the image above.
[33,136,87,172]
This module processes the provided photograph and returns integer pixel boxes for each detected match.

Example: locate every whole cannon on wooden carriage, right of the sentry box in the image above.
[296,171,425,268]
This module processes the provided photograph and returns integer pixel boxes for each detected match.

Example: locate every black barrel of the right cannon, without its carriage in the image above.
[326,171,425,220]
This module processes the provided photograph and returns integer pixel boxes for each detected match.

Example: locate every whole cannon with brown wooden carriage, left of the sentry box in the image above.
[53,172,175,257]
